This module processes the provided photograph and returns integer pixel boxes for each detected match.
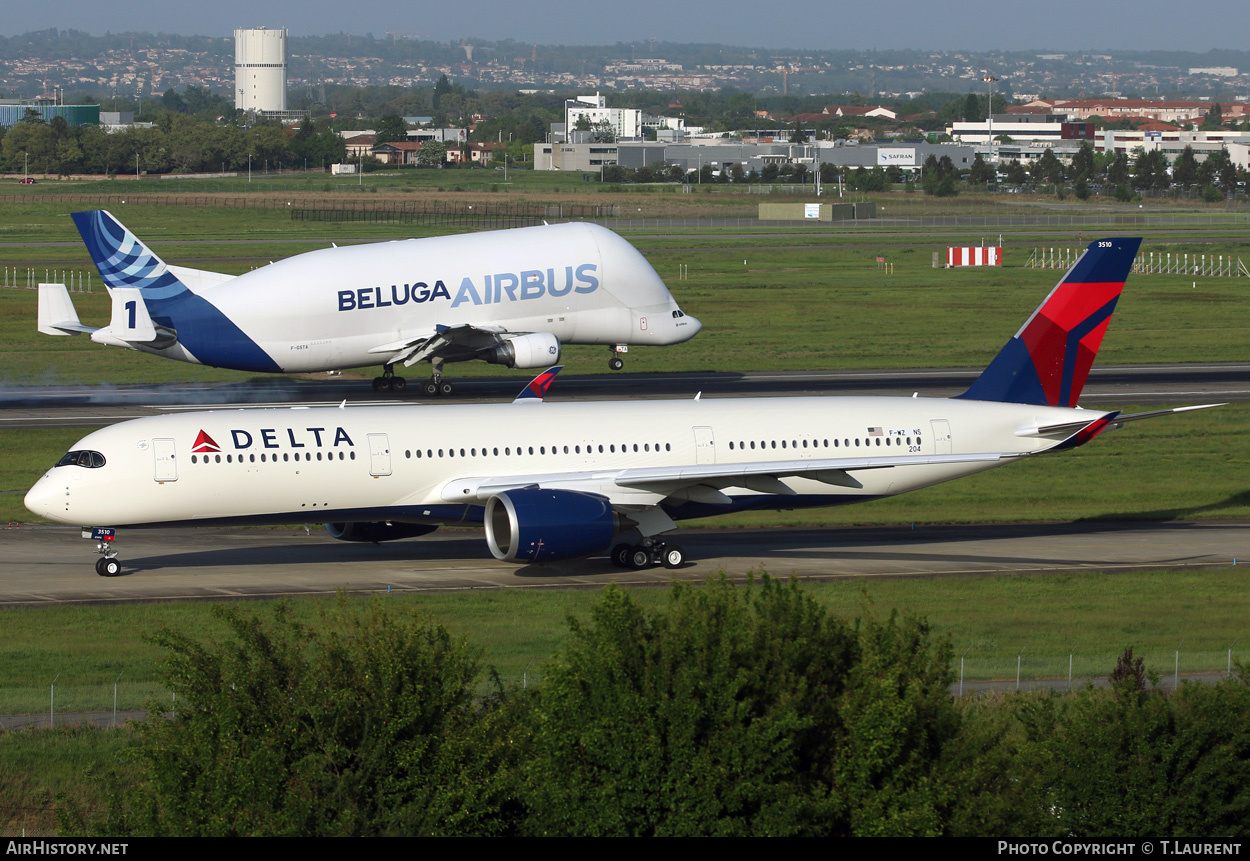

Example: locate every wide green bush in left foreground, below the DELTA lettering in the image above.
[75,597,520,836]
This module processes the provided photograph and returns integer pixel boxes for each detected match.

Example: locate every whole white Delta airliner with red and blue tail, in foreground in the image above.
[26,239,1215,575]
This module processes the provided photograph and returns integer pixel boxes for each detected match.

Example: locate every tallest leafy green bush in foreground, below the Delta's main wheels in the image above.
[525,577,958,835]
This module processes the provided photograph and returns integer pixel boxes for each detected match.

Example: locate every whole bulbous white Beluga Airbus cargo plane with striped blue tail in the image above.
[39,210,700,395]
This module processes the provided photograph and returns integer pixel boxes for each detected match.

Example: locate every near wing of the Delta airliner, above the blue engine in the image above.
[441,452,1023,507]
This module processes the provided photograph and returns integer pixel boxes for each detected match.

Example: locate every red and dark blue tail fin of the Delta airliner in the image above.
[959,239,1141,406]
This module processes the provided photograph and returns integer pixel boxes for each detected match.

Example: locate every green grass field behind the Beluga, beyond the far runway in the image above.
[0,202,1250,385]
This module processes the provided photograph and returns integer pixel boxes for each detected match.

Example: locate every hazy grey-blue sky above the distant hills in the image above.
[0,0,1250,51]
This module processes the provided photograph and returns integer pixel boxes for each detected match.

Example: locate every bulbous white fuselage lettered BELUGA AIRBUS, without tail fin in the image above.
[140,224,700,372]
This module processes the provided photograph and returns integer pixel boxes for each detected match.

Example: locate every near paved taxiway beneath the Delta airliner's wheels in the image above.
[0,520,1250,606]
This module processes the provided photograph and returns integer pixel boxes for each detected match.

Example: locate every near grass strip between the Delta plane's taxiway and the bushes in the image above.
[0,566,1250,714]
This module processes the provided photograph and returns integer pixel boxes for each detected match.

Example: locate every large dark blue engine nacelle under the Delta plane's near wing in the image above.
[485,487,619,562]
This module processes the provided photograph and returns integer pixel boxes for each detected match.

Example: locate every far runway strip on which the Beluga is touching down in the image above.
[0,362,1250,427]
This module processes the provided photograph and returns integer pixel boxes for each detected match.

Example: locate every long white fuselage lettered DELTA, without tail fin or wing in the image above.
[26,397,1099,526]
